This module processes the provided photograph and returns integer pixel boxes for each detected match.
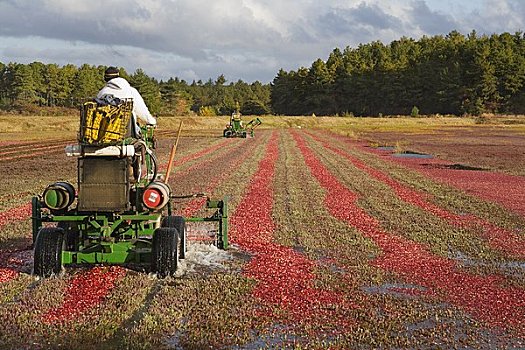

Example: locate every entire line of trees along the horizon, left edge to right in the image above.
[0,31,525,116]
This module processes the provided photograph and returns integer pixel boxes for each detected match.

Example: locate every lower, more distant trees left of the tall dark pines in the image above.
[0,62,271,115]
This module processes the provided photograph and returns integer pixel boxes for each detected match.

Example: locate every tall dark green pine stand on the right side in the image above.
[271,31,525,116]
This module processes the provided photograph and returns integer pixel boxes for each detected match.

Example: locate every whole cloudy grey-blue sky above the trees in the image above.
[0,0,525,83]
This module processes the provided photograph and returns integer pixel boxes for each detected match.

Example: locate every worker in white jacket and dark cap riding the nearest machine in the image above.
[97,67,157,135]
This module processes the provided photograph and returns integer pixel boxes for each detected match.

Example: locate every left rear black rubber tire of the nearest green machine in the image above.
[33,227,64,278]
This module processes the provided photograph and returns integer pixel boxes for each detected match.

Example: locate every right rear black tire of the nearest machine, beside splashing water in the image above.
[151,227,179,278]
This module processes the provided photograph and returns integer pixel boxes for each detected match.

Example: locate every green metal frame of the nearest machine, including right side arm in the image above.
[31,128,228,265]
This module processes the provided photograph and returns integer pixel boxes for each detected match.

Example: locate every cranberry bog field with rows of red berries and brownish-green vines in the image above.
[0,118,525,349]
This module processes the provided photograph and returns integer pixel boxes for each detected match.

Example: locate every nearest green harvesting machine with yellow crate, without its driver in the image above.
[32,99,228,277]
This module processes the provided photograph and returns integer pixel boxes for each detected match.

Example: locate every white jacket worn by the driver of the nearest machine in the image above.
[97,77,157,125]
